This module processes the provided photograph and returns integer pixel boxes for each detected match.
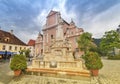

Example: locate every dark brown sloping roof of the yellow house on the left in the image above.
[0,30,26,46]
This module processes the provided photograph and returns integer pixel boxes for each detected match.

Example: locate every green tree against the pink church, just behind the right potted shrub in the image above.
[77,32,95,53]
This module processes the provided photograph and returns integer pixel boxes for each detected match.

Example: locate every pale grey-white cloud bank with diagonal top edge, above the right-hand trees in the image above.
[83,4,120,38]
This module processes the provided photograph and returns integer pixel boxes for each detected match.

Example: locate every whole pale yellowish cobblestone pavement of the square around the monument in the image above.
[0,59,120,84]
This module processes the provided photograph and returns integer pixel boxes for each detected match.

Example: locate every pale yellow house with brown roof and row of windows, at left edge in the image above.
[0,30,28,54]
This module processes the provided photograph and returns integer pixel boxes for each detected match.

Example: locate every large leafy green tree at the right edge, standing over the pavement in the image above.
[100,30,120,55]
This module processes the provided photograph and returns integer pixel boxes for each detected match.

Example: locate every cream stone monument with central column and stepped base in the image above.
[28,17,90,76]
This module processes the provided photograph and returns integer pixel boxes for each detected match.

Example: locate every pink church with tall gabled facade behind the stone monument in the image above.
[36,11,84,55]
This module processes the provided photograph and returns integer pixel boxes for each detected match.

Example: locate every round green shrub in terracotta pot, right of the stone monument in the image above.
[83,52,103,76]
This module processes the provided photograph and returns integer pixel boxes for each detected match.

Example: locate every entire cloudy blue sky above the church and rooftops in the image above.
[0,0,120,43]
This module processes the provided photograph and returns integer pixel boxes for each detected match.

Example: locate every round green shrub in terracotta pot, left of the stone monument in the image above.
[10,54,27,76]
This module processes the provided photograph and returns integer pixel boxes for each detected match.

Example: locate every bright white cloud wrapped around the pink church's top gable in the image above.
[34,0,77,31]
